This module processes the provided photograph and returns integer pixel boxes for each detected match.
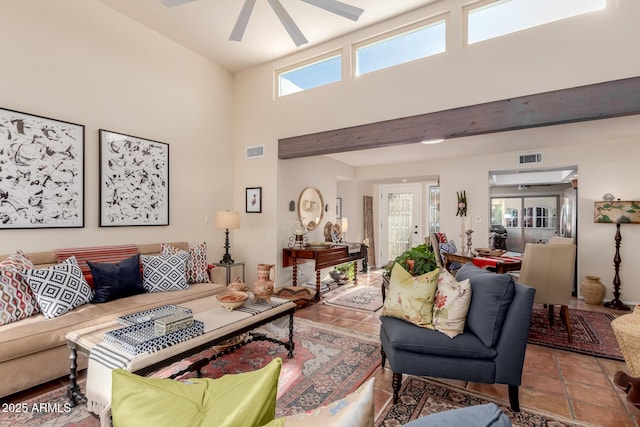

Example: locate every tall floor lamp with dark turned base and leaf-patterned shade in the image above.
[593,200,640,311]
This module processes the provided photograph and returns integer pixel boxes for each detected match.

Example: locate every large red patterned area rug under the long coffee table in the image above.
[0,318,380,427]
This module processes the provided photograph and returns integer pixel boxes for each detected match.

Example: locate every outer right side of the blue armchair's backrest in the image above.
[496,283,536,386]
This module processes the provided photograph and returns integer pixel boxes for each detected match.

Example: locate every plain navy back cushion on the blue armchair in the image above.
[456,262,515,347]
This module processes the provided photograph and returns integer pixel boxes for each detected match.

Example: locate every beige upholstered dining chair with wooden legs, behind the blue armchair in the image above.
[517,242,576,343]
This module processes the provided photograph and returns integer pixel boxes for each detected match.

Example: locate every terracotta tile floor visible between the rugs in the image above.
[8,275,640,427]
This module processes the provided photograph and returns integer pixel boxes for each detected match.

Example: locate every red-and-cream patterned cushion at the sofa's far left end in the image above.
[0,252,40,326]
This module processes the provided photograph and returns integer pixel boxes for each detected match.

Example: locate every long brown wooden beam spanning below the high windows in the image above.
[278,77,640,159]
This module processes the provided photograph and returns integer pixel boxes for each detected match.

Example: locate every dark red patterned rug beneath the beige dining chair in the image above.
[528,304,624,361]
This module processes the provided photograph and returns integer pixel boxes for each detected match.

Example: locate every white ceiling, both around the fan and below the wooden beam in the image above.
[91,0,640,179]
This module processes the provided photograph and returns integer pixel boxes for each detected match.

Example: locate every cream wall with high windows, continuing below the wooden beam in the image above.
[234,0,640,301]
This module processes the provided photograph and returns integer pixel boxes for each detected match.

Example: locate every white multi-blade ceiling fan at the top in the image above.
[161,0,364,47]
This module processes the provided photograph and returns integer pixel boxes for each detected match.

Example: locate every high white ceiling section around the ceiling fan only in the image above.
[98,0,438,72]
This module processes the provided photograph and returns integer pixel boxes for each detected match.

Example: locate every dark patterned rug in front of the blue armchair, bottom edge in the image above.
[375,375,584,427]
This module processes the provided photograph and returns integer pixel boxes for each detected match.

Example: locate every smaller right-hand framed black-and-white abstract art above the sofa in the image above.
[100,129,169,227]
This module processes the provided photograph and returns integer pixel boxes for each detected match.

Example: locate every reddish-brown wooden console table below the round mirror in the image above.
[282,244,367,300]
